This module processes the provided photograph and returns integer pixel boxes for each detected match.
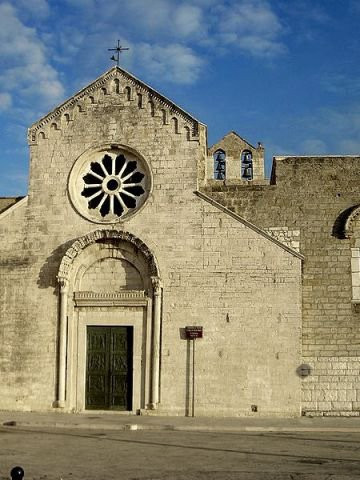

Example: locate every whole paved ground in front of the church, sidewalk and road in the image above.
[0,412,360,480]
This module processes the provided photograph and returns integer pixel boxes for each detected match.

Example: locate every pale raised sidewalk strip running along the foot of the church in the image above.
[0,411,360,433]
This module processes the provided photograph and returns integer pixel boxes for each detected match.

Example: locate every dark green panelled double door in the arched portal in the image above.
[85,326,133,410]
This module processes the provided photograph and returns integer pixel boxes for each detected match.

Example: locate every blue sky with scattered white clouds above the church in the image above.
[0,0,360,196]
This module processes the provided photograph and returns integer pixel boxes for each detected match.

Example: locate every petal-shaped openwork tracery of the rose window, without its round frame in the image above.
[81,154,145,217]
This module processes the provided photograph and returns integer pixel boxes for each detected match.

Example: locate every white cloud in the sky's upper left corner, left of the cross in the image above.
[0,3,64,107]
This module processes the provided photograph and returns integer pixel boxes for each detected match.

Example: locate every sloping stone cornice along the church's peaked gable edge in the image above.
[28,66,205,141]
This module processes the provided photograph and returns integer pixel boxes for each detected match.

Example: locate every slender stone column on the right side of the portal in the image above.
[150,277,161,409]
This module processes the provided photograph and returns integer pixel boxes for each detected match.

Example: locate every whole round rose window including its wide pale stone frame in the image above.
[69,146,151,223]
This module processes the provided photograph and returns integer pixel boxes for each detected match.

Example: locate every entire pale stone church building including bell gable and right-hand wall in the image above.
[0,67,360,416]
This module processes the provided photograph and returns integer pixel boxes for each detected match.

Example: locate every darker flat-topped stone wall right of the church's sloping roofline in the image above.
[206,157,360,415]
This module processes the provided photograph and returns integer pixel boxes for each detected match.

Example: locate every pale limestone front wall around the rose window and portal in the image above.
[0,69,301,415]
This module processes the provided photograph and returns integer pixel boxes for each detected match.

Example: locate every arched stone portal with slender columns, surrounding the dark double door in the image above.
[56,230,162,413]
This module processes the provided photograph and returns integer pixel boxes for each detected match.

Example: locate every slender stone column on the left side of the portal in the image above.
[56,279,69,408]
